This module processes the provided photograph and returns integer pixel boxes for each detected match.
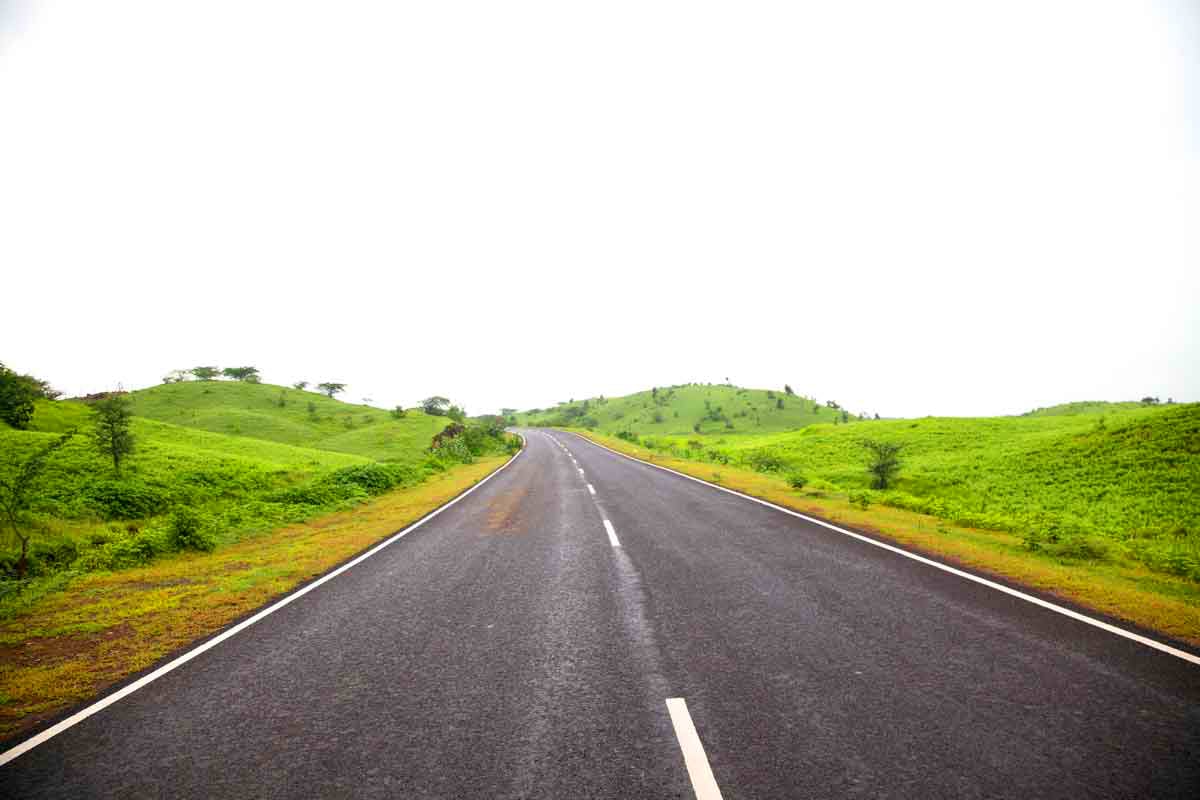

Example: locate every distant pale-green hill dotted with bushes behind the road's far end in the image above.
[517,384,857,435]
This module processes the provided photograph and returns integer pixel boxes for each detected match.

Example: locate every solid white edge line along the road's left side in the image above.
[0,434,528,766]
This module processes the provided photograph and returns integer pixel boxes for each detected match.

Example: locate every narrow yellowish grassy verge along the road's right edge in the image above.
[572,431,1200,645]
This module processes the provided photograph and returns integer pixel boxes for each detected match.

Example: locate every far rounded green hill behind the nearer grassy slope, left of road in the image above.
[130,380,450,463]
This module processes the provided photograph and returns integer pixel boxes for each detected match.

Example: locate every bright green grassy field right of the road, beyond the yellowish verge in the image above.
[552,401,1200,581]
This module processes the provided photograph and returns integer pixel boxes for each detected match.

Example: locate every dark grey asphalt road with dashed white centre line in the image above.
[0,431,1200,800]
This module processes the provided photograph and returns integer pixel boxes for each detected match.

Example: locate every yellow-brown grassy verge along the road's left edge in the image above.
[0,456,508,739]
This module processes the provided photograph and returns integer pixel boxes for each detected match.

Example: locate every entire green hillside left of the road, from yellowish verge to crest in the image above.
[0,381,505,592]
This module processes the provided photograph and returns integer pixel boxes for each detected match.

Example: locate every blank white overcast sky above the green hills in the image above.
[0,0,1200,416]
